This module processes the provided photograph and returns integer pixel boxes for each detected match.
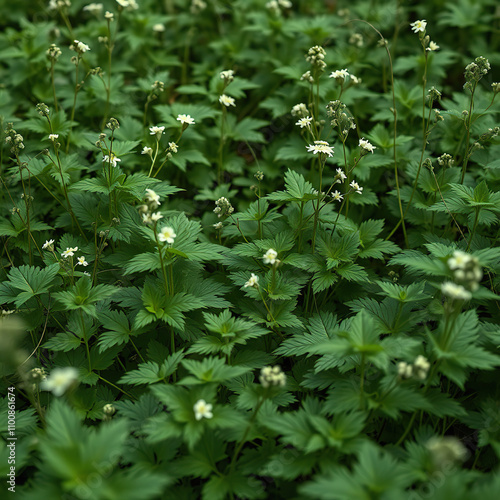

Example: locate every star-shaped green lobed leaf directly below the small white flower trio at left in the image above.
[53,276,118,317]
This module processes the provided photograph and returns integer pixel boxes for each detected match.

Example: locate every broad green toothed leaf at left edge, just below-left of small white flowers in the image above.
[0,263,60,307]
